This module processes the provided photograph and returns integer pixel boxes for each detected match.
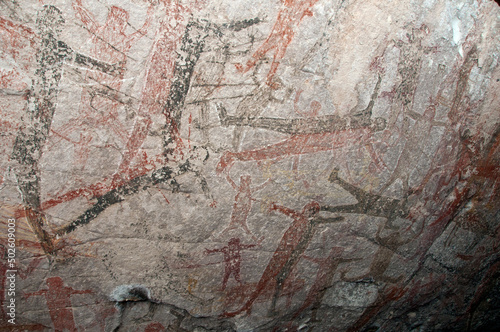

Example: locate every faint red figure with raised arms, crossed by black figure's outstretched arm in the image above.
[53,0,153,174]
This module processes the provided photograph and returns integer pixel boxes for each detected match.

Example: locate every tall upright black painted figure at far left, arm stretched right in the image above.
[11,5,122,253]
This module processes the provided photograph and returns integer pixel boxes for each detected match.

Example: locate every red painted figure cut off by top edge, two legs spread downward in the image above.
[236,0,318,86]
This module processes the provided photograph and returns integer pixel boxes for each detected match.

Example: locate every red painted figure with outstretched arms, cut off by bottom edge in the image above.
[25,277,92,332]
